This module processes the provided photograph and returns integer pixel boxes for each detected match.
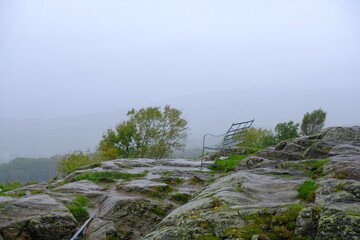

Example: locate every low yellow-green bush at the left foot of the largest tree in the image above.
[58,151,101,173]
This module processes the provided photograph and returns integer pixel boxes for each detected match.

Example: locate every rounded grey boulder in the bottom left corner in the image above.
[0,194,77,240]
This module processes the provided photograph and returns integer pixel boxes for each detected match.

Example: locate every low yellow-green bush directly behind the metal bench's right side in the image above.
[246,127,276,149]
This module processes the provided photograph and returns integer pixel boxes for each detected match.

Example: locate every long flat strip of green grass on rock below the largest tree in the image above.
[75,171,148,183]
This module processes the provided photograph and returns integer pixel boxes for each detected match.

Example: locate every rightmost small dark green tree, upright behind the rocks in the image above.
[300,108,326,135]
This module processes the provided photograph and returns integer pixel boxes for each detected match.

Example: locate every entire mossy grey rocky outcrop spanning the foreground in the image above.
[0,127,360,240]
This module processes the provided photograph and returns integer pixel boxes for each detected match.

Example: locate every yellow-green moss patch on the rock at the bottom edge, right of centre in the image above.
[223,204,308,240]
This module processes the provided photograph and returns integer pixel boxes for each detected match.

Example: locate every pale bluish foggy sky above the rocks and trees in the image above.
[0,0,360,161]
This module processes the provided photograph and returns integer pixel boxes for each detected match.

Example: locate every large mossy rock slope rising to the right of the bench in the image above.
[145,127,360,240]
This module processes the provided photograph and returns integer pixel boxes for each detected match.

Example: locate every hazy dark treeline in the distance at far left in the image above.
[0,155,62,184]
